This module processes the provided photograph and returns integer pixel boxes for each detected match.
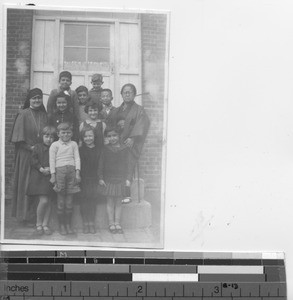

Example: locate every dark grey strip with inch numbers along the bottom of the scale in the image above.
[0,281,286,297]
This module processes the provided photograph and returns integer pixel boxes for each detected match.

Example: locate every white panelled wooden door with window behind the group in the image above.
[31,15,141,106]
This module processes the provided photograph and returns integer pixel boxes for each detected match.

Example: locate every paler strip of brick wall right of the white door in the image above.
[140,14,167,202]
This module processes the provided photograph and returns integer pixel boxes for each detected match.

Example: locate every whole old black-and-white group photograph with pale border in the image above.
[1,6,169,248]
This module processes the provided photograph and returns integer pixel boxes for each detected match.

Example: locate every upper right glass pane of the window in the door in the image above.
[88,25,110,47]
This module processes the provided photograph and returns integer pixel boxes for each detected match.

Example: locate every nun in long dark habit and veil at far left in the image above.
[10,88,47,221]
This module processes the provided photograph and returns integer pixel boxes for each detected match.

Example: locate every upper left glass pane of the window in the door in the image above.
[64,24,86,46]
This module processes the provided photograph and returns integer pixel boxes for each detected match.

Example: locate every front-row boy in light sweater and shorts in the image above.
[49,123,80,235]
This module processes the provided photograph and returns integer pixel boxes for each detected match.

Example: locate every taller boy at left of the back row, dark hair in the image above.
[47,71,79,120]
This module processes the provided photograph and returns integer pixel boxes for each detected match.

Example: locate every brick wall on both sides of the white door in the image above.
[5,9,166,202]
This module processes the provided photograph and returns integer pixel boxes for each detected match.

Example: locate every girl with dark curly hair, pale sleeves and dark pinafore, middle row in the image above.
[79,100,106,149]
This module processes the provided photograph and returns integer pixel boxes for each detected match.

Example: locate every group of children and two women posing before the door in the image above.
[10,71,150,235]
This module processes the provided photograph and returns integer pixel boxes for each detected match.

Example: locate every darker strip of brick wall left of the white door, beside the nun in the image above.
[5,9,33,198]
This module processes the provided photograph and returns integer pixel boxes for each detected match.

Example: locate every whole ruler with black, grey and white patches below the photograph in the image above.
[0,251,287,300]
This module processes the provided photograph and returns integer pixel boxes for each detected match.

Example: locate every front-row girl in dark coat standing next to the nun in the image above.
[27,126,56,235]
